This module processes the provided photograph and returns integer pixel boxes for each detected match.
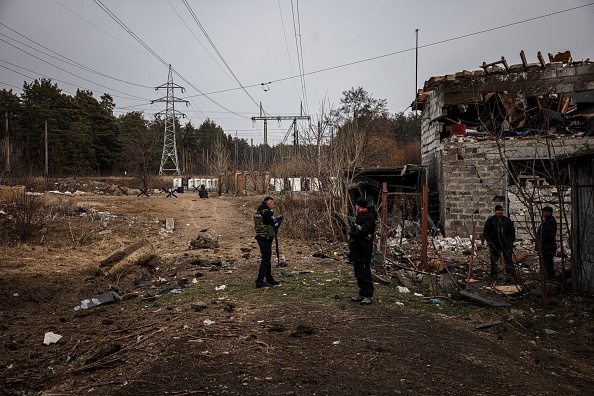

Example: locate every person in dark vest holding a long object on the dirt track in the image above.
[254,197,283,288]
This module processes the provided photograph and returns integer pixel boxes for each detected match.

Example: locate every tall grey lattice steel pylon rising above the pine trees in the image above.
[151,65,188,175]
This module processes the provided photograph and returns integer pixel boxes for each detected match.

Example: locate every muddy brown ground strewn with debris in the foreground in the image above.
[0,181,594,395]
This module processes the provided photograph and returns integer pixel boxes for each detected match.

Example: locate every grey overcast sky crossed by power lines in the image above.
[0,0,594,145]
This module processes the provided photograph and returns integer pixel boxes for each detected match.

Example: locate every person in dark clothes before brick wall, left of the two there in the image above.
[483,205,516,279]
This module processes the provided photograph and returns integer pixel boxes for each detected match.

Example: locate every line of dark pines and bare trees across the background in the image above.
[0,78,420,183]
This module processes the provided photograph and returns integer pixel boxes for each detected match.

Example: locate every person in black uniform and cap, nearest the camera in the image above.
[348,197,375,304]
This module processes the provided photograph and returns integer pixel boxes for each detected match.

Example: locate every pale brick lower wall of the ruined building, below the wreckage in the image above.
[437,138,594,240]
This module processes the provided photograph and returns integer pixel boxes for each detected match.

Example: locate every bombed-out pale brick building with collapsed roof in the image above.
[414,51,594,244]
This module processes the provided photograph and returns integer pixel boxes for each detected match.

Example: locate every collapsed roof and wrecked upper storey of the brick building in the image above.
[412,51,594,138]
